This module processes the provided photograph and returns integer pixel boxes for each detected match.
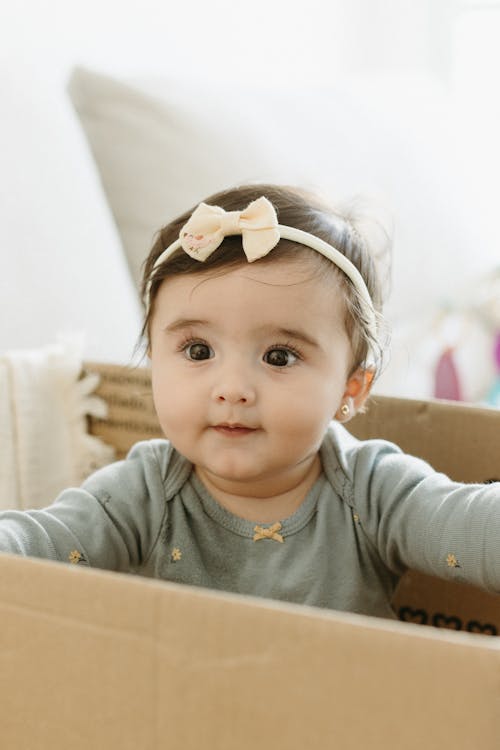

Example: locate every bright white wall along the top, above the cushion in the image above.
[0,0,453,83]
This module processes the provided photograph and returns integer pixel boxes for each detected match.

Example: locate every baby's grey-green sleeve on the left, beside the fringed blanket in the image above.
[0,441,167,571]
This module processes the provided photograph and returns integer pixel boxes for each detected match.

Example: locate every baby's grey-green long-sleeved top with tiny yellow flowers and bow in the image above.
[0,424,500,617]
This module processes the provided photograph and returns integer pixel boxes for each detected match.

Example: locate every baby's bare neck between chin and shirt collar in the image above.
[195,455,321,524]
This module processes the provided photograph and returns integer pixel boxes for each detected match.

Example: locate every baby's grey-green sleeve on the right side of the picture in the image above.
[353,441,500,593]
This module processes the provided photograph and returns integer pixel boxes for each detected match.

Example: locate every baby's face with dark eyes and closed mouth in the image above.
[150,261,351,496]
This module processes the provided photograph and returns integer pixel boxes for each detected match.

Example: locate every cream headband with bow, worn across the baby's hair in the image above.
[146,196,377,335]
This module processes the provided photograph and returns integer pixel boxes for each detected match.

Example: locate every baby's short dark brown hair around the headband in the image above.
[142,184,389,372]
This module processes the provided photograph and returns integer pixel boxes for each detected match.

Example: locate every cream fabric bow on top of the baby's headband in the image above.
[179,196,280,263]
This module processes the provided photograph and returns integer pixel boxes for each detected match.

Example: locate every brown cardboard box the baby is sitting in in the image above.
[0,365,500,750]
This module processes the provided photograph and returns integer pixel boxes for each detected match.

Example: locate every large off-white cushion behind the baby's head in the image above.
[69,68,495,396]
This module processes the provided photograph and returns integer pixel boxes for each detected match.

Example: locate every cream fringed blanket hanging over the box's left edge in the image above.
[0,341,114,509]
